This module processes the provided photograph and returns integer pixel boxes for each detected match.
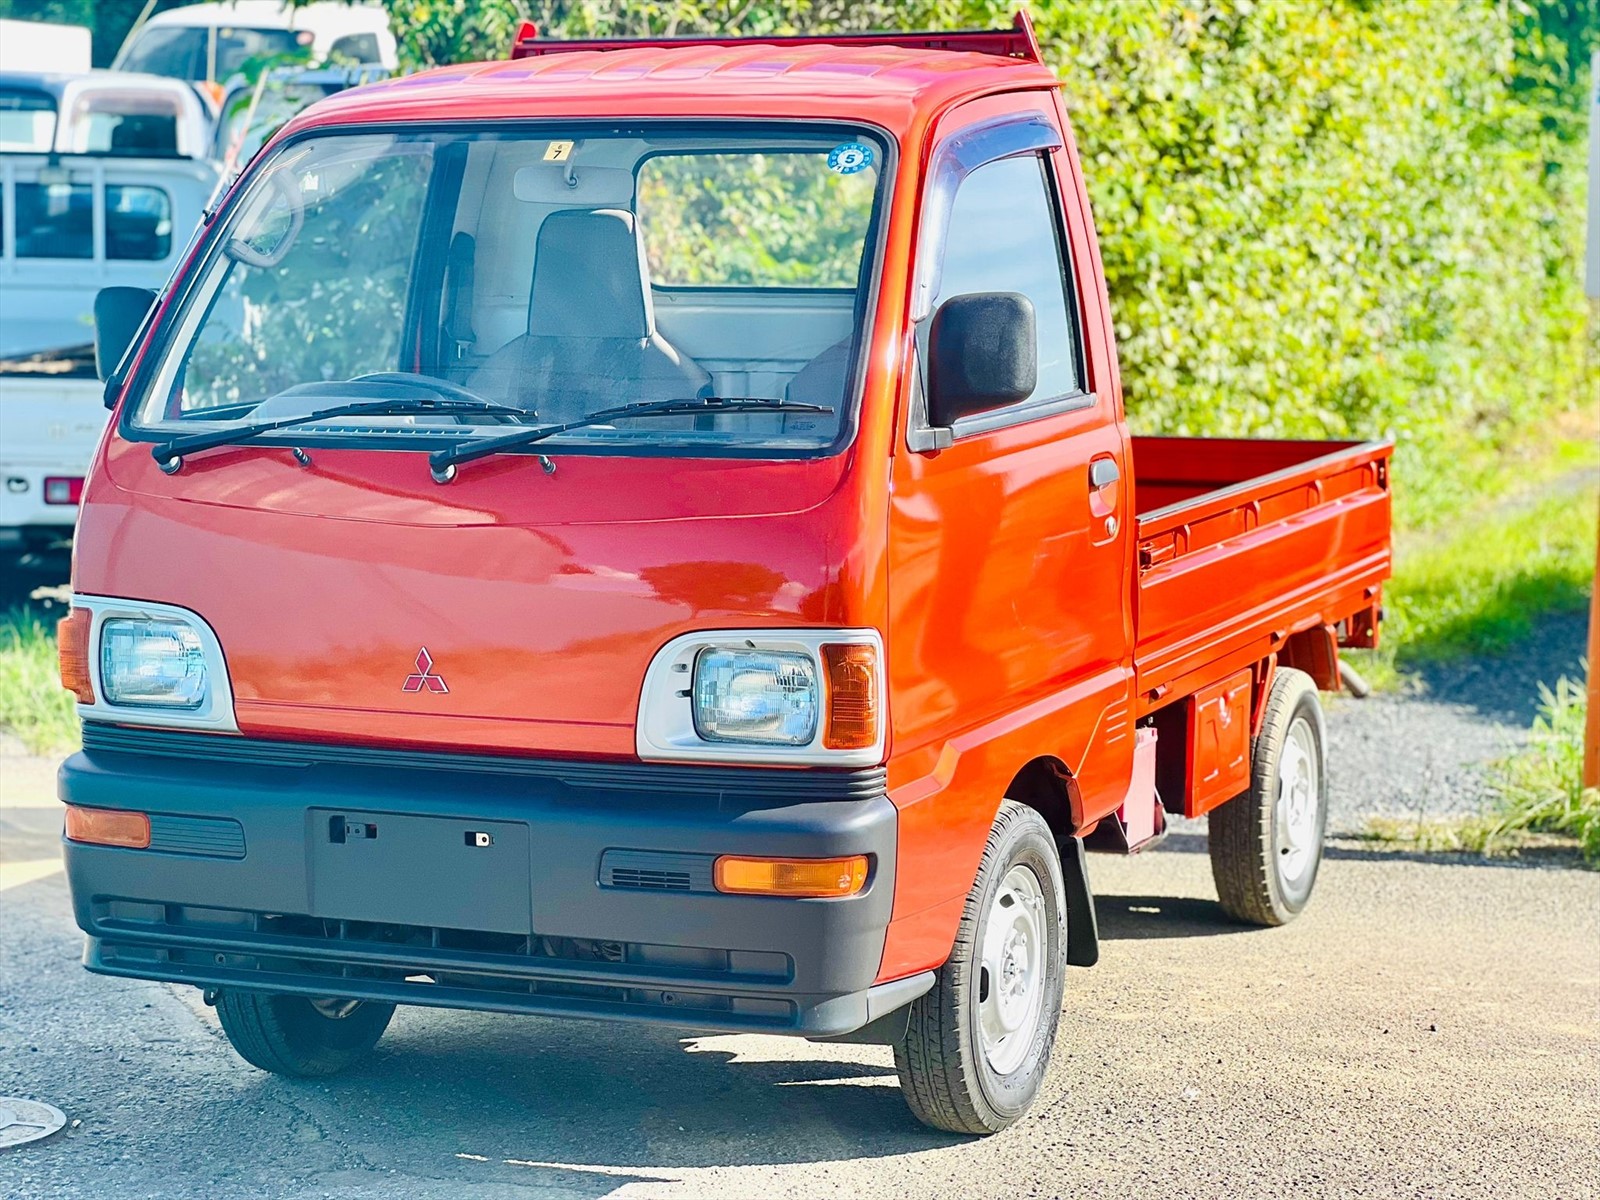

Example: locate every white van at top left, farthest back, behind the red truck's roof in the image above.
[112,0,397,101]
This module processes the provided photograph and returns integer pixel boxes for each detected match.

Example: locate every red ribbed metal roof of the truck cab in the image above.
[288,23,1056,131]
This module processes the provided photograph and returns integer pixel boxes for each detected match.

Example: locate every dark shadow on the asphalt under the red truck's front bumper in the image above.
[280,1008,965,1197]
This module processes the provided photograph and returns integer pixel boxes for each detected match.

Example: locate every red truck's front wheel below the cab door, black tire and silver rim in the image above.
[894,800,1067,1134]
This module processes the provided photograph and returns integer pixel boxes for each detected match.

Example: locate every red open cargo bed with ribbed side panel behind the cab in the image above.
[1133,437,1394,715]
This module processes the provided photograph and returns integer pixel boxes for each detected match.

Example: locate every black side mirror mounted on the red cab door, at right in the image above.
[928,291,1038,427]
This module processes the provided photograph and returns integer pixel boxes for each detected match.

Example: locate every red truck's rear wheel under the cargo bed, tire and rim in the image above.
[1208,667,1328,926]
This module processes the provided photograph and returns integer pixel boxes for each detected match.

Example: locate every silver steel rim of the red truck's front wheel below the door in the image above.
[978,866,1046,1075]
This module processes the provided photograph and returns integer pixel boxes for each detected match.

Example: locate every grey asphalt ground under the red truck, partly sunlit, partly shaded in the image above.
[0,757,1600,1200]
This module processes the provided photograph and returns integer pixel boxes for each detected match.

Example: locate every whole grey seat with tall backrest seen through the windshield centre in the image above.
[467,208,710,421]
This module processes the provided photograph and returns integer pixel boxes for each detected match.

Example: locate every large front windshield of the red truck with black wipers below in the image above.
[130,125,885,454]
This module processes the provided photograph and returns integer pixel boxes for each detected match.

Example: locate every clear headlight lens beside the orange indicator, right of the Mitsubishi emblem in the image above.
[693,646,822,746]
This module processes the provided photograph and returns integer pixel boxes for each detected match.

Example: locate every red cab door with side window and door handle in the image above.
[888,93,1134,904]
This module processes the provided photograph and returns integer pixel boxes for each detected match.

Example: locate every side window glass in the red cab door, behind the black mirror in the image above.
[918,154,1090,427]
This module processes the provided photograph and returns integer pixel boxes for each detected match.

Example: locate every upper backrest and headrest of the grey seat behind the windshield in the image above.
[528,208,654,341]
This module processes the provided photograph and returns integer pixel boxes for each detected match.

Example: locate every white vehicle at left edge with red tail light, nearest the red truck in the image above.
[0,75,218,565]
